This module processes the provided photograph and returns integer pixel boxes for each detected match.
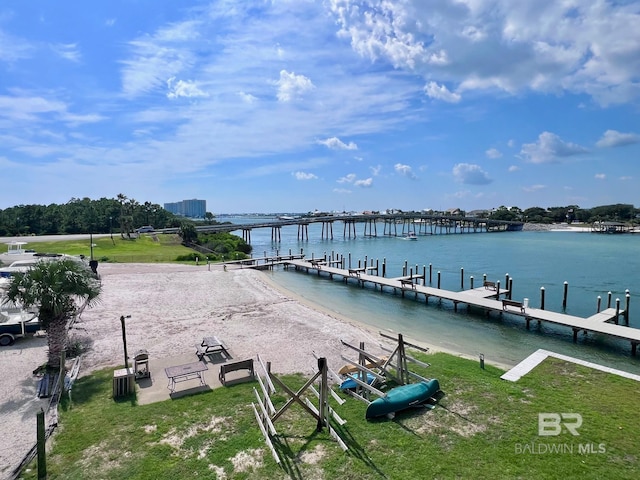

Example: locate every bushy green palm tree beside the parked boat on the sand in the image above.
[4,259,102,369]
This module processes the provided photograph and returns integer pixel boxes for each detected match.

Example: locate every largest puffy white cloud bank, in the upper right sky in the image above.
[330,0,640,105]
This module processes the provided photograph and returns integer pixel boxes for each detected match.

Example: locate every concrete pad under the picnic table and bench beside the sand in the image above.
[136,349,234,405]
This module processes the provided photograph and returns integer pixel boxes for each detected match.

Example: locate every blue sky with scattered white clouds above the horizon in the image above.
[0,0,640,214]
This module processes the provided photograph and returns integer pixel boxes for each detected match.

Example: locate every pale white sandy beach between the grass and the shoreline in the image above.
[0,264,410,478]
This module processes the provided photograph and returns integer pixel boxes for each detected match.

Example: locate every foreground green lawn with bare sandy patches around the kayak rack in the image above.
[23,353,640,480]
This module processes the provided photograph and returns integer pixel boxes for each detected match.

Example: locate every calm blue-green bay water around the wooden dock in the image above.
[224,217,640,374]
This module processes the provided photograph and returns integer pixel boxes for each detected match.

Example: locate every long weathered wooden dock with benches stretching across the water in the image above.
[283,259,640,355]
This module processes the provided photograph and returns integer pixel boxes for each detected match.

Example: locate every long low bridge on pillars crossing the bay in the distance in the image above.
[161,213,523,243]
